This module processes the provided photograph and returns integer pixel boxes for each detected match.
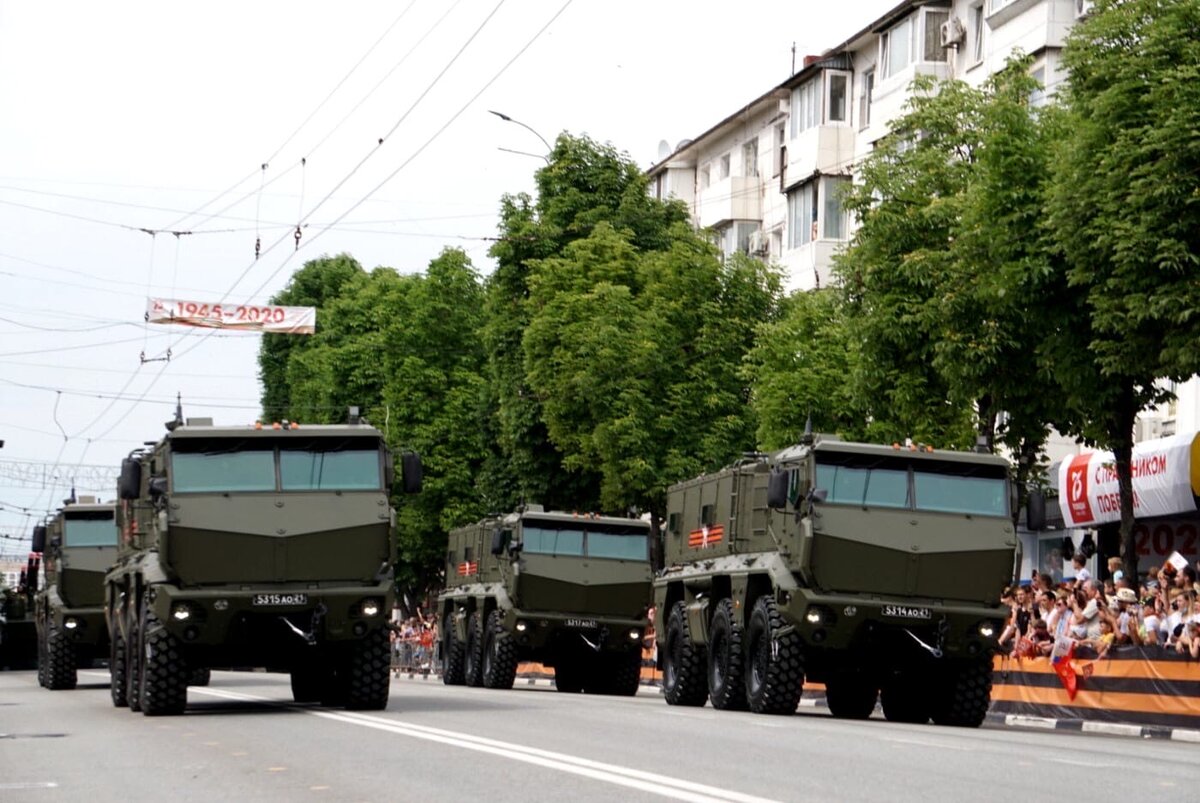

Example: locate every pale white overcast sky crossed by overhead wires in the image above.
[0,0,899,547]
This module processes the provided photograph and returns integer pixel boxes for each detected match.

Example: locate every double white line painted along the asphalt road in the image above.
[188,688,769,803]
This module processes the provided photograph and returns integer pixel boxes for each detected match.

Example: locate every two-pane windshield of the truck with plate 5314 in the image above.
[816,454,1008,516]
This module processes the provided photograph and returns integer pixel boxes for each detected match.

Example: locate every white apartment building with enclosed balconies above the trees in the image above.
[648,0,1088,290]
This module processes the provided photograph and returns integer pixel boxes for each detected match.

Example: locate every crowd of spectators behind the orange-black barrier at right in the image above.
[1000,555,1200,659]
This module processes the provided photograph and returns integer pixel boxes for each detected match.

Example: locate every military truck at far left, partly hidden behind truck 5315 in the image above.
[34,495,116,690]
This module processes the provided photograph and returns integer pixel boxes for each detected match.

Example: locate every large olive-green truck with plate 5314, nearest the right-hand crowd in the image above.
[654,436,1018,726]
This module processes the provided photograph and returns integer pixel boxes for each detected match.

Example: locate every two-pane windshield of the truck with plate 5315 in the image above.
[170,436,383,493]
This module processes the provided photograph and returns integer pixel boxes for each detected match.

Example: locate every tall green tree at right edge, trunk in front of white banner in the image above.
[1050,0,1200,576]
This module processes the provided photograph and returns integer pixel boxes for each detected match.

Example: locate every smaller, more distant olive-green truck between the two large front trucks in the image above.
[438,505,652,695]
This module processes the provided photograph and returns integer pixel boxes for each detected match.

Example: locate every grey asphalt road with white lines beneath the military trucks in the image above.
[0,670,1200,803]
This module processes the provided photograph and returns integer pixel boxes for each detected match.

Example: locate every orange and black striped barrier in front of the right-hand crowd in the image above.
[990,647,1200,729]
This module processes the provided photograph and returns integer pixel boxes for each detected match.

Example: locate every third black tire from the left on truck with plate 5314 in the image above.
[744,594,804,714]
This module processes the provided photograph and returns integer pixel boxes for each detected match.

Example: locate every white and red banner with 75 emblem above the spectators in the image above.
[1058,432,1200,527]
